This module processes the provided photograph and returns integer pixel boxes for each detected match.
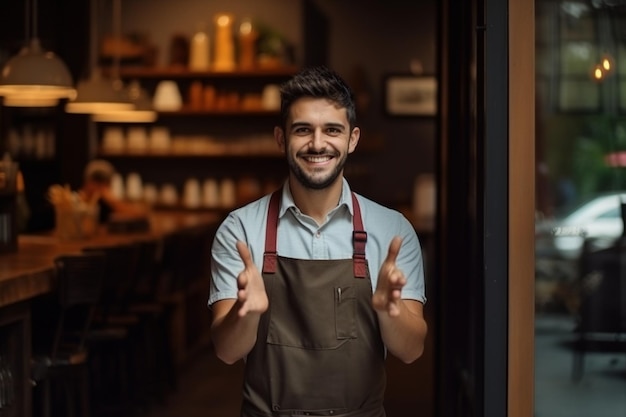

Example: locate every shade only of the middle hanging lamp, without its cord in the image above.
[65,70,134,114]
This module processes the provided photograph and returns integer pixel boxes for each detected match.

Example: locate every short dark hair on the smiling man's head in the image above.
[280,66,356,129]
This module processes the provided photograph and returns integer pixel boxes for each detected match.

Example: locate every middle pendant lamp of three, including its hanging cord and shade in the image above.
[65,0,133,114]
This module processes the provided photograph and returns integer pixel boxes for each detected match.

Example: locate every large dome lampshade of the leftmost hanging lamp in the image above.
[0,38,76,100]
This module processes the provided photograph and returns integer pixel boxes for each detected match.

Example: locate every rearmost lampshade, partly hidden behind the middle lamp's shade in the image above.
[92,80,157,123]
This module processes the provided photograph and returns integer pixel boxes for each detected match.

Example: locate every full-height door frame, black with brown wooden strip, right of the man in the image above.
[435,0,535,417]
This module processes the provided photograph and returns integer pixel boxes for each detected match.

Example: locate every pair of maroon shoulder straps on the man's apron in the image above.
[263,188,367,278]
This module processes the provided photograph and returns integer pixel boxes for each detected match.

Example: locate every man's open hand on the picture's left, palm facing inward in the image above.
[232,241,269,317]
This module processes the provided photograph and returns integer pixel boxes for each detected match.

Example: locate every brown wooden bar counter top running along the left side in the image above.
[0,211,222,308]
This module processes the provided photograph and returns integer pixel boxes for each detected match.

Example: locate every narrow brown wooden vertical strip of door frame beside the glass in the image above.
[507,0,535,417]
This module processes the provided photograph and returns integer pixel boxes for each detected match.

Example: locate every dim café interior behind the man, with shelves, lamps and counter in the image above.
[0,0,436,417]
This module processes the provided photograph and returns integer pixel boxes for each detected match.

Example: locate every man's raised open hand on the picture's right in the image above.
[372,236,406,317]
